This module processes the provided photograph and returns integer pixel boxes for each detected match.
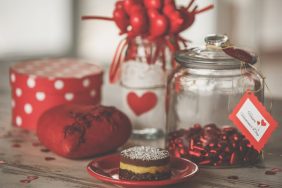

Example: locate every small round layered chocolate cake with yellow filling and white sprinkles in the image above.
[119,146,171,181]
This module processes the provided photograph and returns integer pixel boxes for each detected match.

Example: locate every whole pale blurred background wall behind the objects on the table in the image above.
[0,0,282,98]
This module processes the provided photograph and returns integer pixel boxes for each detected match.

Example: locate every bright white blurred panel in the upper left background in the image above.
[0,0,73,59]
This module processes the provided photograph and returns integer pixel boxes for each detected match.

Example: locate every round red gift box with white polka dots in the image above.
[10,58,103,131]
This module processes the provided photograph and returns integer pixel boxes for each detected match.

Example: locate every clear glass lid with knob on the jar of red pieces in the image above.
[175,34,257,69]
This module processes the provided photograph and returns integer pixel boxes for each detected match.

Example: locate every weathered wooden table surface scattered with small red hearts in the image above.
[0,62,282,188]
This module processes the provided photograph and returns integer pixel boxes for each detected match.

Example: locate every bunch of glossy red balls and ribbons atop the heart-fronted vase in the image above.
[82,0,213,83]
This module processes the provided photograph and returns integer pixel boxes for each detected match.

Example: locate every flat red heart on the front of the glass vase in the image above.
[127,92,158,116]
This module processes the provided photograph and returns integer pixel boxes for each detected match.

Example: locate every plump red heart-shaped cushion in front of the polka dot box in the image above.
[37,105,131,158]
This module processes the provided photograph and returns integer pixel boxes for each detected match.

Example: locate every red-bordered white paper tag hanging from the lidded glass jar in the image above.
[229,91,277,151]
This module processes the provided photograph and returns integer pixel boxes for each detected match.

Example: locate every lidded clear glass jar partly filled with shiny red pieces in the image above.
[166,35,264,166]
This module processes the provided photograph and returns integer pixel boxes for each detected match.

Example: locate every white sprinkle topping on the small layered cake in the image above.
[121,146,169,161]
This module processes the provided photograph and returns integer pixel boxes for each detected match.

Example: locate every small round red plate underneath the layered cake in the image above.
[87,154,198,187]
